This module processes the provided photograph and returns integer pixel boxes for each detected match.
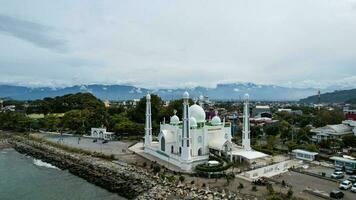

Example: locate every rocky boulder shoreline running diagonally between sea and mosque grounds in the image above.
[9,137,256,200]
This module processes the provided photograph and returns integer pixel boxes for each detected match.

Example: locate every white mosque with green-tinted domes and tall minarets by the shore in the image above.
[144,92,267,172]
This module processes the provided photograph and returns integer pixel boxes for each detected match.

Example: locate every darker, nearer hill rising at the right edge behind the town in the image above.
[300,89,356,103]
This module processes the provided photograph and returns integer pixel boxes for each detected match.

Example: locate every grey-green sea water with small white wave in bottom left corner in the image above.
[0,149,125,200]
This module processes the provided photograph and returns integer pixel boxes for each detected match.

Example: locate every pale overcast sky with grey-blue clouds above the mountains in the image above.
[0,0,356,88]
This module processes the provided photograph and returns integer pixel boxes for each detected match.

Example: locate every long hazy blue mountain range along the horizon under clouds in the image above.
[0,83,317,101]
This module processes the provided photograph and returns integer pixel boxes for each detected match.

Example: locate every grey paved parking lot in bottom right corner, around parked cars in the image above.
[275,171,356,200]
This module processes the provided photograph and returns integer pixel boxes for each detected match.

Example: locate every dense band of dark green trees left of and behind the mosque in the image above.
[0,93,192,136]
